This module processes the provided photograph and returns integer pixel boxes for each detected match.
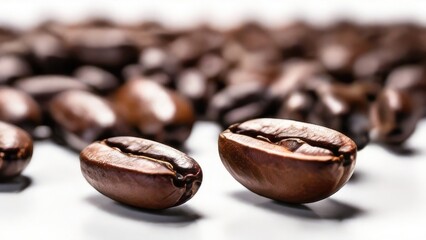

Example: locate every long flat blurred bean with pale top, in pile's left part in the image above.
[13,75,89,109]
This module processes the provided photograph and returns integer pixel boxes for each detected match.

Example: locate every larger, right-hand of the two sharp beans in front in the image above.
[219,118,357,203]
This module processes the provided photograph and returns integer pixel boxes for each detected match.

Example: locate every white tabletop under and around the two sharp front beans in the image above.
[0,121,426,240]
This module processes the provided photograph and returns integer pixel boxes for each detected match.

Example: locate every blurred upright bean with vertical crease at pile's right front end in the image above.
[370,89,421,144]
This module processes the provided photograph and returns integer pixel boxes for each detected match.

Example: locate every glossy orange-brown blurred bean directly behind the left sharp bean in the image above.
[112,79,195,145]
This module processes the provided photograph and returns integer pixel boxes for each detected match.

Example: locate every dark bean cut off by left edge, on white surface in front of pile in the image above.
[0,122,33,181]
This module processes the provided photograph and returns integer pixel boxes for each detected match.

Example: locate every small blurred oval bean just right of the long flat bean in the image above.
[74,66,120,94]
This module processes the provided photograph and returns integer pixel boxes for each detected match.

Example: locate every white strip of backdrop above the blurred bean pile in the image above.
[0,0,426,27]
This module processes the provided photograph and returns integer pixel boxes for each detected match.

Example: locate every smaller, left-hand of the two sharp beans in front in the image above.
[80,137,202,209]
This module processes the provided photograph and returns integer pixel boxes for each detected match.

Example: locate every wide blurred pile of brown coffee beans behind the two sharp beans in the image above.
[0,19,426,181]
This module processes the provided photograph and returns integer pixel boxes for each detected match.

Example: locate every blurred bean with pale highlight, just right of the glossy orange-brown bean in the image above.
[176,69,217,115]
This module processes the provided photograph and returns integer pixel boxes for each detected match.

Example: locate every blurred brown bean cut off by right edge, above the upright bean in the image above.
[385,65,426,115]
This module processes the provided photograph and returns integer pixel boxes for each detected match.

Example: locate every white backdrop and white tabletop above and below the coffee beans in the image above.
[0,0,426,240]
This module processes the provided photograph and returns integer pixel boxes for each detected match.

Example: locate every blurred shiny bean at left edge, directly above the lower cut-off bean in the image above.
[0,87,42,136]
